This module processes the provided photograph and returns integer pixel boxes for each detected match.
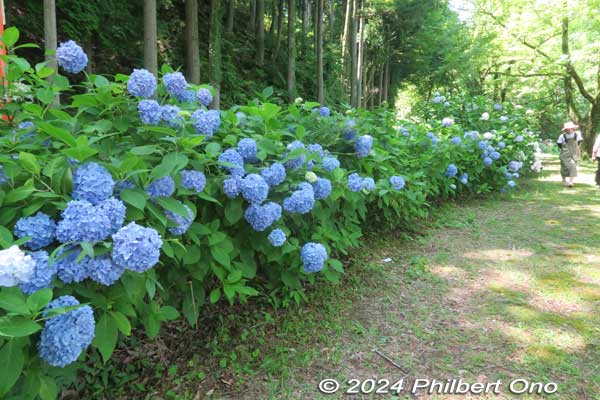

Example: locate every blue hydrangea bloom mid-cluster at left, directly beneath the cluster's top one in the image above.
[56,200,112,243]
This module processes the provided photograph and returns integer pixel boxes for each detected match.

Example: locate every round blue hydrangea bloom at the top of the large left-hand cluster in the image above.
[73,163,115,204]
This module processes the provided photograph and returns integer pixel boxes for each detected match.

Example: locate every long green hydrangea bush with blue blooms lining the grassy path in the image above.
[0,28,536,399]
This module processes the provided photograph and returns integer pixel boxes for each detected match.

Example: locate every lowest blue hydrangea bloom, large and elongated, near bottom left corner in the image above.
[38,296,96,368]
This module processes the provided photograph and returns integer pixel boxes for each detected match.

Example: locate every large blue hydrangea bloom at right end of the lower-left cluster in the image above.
[112,222,162,272]
